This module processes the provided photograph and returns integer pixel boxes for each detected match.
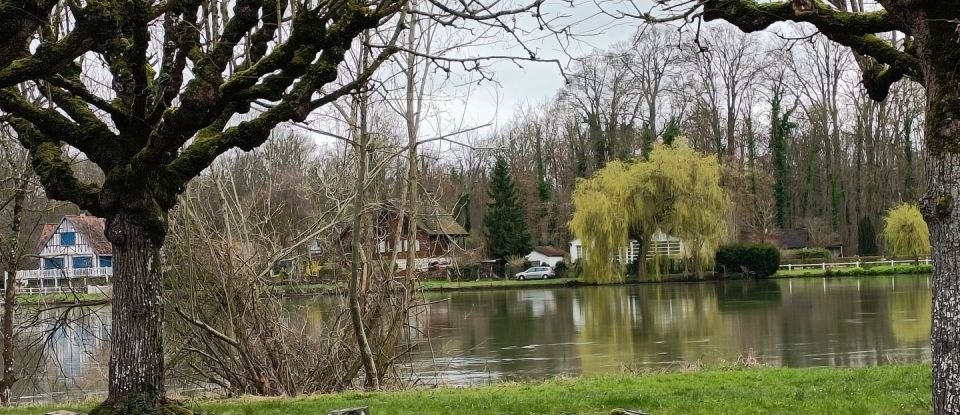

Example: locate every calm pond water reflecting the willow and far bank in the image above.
[9,276,931,401]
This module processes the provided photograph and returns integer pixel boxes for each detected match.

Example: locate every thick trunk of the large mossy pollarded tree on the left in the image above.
[91,213,170,415]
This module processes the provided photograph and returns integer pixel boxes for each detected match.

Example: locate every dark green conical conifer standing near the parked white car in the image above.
[483,156,532,258]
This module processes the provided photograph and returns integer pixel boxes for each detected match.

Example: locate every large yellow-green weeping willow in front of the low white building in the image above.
[570,140,730,283]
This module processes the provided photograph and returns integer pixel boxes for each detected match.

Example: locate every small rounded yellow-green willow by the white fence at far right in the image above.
[883,203,930,258]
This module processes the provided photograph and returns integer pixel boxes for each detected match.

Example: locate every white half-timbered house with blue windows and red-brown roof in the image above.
[17,214,113,293]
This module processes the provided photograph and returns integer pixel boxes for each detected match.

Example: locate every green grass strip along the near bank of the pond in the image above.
[0,365,930,415]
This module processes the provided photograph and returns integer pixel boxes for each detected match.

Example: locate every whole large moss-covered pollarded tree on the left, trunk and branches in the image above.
[0,0,556,414]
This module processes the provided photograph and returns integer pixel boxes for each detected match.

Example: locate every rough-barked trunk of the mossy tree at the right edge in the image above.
[915,14,960,415]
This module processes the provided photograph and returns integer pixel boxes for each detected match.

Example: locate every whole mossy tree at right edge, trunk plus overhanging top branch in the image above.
[633,0,960,414]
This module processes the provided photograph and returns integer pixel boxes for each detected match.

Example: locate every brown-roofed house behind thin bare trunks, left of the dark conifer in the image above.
[340,200,469,270]
